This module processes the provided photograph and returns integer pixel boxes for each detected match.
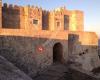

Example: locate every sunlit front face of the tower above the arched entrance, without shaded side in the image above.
[49,7,64,31]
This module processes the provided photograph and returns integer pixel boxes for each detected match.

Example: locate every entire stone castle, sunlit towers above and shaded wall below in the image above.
[0,0,100,77]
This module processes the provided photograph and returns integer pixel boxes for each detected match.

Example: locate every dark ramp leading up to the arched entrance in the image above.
[34,63,68,80]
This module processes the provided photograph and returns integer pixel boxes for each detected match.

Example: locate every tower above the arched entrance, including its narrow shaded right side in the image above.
[49,7,70,31]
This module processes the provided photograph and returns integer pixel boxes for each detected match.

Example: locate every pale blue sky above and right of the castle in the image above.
[3,0,100,35]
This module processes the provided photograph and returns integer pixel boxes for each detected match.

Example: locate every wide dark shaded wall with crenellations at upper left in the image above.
[2,3,21,29]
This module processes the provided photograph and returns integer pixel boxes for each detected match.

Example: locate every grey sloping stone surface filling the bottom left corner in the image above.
[0,56,32,80]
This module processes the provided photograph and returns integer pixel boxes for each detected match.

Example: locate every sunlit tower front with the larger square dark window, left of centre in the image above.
[28,6,42,30]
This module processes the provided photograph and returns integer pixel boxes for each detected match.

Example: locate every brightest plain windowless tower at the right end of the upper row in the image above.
[69,10,84,31]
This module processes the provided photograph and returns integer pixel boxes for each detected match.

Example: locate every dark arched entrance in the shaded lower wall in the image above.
[53,43,63,63]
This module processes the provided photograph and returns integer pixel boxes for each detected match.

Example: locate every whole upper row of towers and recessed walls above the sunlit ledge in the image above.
[1,3,83,31]
